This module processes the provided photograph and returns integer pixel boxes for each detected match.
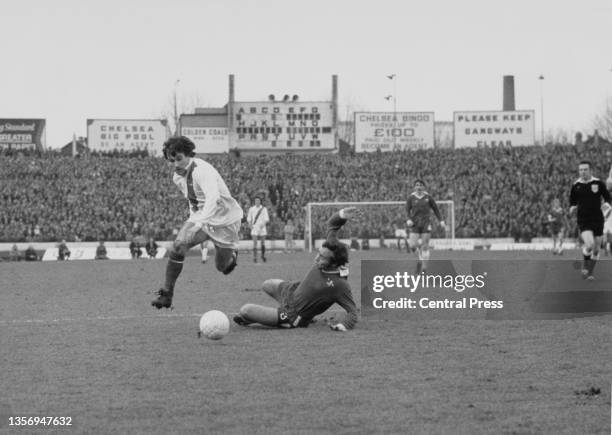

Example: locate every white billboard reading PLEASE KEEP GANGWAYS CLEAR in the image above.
[454,110,535,148]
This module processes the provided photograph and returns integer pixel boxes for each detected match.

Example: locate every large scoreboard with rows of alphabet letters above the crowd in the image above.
[231,101,336,151]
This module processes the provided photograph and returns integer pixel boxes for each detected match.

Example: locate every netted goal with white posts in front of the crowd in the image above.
[304,201,455,252]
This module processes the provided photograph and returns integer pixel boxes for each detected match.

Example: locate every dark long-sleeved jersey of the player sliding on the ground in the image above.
[287,213,357,329]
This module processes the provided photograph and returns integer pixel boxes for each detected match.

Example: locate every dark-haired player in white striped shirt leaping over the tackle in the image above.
[151,136,243,309]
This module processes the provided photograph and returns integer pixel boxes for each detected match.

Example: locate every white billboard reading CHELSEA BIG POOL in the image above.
[87,119,170,155]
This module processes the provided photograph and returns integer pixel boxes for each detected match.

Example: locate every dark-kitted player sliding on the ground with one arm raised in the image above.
[234,207,358,332]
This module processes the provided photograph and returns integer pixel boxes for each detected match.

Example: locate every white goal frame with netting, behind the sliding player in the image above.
[304,201,455,252]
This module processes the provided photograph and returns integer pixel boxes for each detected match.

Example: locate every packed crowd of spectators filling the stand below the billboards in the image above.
[0,145,611,242]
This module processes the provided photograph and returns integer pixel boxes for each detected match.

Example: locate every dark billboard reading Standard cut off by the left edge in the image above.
[0,119,46,151]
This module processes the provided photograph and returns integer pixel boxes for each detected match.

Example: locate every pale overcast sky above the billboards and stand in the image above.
[0,0,612,147]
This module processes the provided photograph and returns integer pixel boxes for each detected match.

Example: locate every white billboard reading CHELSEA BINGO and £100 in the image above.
[355,112,434,153]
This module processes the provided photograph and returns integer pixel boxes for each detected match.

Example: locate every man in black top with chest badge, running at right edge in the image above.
[569,160,610,280]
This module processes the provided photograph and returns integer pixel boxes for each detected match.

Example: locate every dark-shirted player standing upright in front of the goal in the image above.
[406,180,446,273]
